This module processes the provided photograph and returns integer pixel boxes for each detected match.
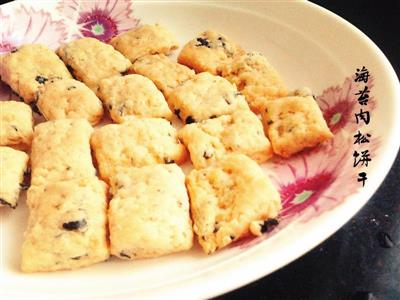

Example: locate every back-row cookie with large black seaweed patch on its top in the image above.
[178,30,245,75]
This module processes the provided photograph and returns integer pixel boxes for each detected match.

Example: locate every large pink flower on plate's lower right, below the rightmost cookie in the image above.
[271,134,354,220]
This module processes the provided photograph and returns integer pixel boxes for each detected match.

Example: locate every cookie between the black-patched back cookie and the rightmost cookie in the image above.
[221,52,288,113]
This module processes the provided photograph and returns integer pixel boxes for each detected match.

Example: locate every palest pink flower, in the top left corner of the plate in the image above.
[0,5,67,55]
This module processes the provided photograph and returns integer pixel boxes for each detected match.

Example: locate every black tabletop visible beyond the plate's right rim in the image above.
[218,0,400,300]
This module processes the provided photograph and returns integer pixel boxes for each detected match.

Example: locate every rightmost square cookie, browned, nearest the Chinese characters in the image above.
[262,96,333,157]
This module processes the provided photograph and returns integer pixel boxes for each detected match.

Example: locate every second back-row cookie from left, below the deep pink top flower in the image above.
[57,38,131,94]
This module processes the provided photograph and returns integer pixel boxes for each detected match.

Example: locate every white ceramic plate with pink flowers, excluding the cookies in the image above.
[0,0,400,299]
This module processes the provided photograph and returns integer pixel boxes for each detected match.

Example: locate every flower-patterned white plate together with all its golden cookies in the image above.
[0,0,400,299]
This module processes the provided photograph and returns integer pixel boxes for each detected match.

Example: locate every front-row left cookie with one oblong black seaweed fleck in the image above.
[21,178,109,272]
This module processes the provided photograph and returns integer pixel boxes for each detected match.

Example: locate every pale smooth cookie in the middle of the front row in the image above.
[108,164,193,259]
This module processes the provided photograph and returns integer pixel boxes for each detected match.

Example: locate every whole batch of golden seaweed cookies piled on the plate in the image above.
[0,24,332,272]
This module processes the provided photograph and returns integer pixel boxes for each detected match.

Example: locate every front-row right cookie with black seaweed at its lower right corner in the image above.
[186,154,281,254]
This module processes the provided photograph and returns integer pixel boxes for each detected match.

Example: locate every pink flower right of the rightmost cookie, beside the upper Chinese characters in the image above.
[317,77,375,134]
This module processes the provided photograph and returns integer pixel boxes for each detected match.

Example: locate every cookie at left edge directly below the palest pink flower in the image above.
[0,44,72,103]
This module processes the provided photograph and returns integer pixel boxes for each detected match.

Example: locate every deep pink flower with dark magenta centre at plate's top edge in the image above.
[58,0,139,41]
